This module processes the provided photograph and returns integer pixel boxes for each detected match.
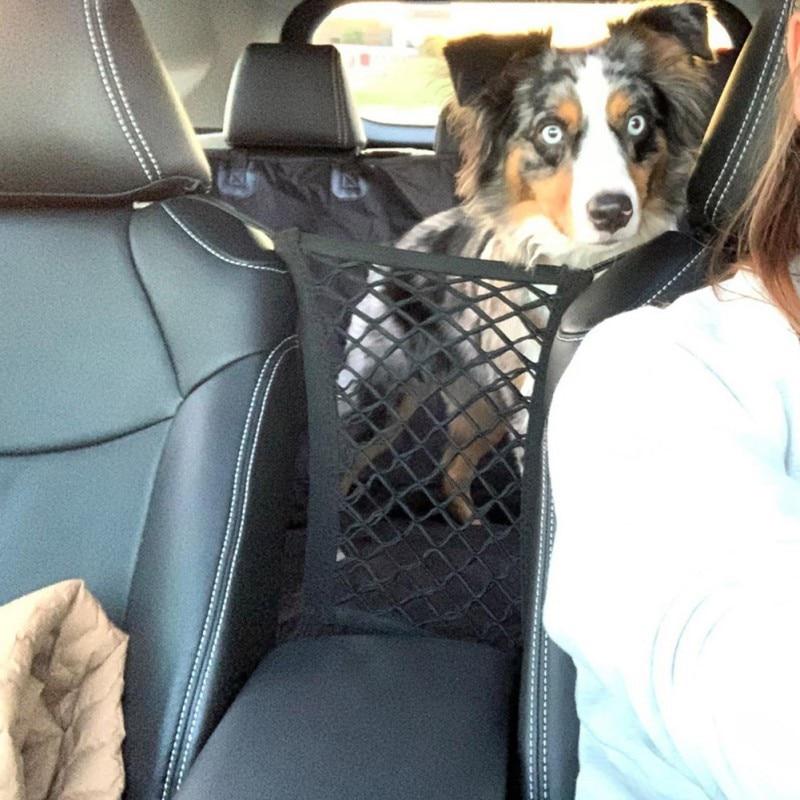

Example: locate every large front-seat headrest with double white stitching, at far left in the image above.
[0,0,210,205]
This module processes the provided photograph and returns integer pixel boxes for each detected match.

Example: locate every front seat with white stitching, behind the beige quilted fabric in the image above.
[0,0,302,800]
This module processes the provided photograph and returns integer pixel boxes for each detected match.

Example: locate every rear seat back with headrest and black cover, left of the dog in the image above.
[202,43,457,242]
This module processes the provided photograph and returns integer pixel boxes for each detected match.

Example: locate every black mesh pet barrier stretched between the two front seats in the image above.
[276,231,591,647]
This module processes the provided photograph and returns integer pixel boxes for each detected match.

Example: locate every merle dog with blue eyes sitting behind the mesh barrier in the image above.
[338,2,714,523]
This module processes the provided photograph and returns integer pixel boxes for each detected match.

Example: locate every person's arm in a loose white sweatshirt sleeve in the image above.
[547,310,800,800]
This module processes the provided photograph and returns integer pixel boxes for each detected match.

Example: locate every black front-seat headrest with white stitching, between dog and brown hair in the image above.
[689,0,793,228]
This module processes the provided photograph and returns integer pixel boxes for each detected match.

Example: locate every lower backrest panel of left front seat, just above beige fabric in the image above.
[0,422,170,625]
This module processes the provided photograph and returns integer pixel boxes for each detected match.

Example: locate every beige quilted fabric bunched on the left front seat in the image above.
[0,581,128,800]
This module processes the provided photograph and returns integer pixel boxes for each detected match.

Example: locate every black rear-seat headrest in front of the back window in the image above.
[225,44,366,150]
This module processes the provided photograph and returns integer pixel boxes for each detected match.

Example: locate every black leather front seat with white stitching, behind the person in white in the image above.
[519,0,792,800]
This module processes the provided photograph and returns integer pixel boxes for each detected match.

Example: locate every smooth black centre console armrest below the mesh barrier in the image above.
[179,636,515,800]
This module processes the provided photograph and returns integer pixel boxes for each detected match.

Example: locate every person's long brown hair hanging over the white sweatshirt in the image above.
[714,69,800,334]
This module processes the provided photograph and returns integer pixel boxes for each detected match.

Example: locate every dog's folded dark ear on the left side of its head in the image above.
[444,31,550,105]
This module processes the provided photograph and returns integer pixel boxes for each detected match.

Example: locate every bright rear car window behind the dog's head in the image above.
[312,2,731,126]
